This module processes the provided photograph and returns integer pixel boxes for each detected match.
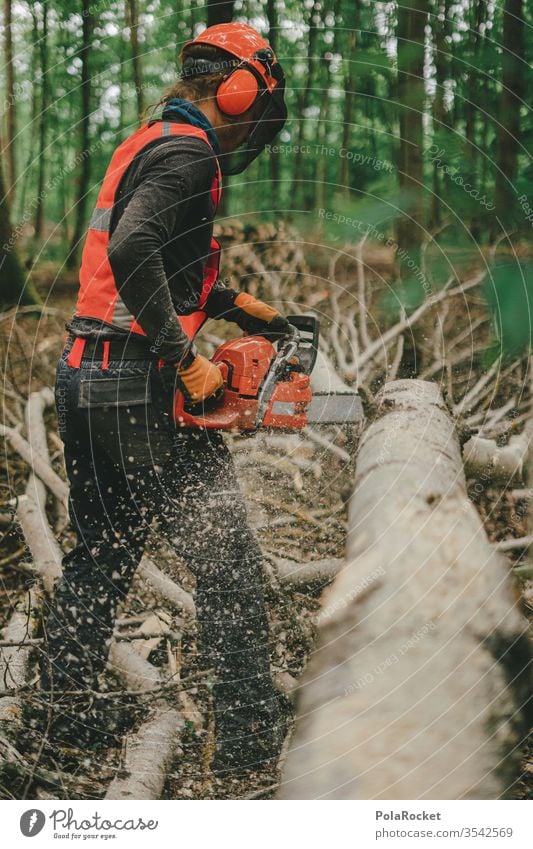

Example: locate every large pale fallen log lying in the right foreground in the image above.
[280,380,531,799]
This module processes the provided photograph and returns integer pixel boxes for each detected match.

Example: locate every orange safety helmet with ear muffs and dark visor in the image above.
[180,23,287,174]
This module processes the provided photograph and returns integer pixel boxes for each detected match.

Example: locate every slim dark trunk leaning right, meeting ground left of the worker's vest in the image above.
[66,0,96,270]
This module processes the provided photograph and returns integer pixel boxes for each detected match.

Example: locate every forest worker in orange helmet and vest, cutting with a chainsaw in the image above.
[41,23,290,772]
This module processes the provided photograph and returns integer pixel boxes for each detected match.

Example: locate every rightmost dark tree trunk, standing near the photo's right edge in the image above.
[495,0,526,222]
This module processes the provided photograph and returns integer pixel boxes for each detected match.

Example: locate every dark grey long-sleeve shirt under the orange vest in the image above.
[69,118,276,363]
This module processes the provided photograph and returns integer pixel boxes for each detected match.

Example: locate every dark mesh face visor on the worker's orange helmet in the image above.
[220,77,287,176]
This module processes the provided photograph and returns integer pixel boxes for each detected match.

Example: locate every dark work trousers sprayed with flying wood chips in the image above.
[42,344,279,760]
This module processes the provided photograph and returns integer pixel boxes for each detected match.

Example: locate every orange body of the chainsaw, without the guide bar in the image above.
[174,336,312,431]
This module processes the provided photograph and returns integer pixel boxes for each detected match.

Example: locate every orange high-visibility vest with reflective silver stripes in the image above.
[76,121,221,339]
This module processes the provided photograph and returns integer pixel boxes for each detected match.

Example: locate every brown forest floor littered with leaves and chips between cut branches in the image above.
[0,235,533,799]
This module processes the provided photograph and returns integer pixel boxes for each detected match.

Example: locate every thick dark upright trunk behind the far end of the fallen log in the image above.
[397,0,428,265]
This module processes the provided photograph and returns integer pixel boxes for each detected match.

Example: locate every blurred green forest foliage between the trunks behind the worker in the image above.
[1,0,533,274]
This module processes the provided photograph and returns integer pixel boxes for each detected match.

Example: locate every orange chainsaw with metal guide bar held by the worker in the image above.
[174,315,363,433]
